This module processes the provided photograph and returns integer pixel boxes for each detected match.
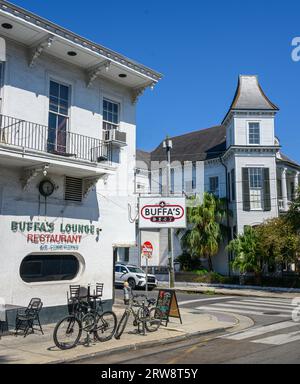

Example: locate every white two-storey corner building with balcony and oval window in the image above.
[0,1,161,320]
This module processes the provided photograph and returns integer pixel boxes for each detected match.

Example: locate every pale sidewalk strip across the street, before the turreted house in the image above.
[158,281,300,299]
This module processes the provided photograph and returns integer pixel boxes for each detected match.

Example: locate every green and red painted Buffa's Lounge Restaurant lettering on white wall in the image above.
[11,221,101,250]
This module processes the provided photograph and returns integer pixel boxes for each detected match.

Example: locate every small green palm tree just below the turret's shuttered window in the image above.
[227,227,264,278]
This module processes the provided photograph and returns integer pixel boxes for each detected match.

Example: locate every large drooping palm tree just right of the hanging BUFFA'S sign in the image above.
[177,193,226,271]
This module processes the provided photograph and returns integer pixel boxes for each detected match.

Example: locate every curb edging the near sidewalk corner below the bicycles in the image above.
[46,324,237,365]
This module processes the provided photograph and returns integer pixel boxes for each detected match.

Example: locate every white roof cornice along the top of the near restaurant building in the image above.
[0,0,162,82]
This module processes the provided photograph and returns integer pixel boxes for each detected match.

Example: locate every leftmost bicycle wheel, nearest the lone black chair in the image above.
[53,316,82,350]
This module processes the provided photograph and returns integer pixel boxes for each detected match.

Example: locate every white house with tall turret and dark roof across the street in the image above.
[131,76,300,274]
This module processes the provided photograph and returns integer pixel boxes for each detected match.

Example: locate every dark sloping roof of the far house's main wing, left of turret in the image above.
[151,125,226,162]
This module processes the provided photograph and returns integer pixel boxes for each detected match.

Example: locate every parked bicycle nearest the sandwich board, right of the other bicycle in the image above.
[115,295,162,340]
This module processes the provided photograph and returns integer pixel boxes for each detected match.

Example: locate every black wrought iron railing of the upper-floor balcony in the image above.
[0,115,111,163]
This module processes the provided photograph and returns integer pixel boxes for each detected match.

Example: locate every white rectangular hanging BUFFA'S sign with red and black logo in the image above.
[139,197,186,229]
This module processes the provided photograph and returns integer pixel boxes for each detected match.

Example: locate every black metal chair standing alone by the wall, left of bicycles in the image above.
[15,298,44,337]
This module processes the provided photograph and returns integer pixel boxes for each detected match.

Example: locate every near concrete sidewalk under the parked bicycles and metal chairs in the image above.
[0,305,240,364]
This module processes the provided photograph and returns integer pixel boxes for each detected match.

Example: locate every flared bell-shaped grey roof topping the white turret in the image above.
[223,75,279,122]
